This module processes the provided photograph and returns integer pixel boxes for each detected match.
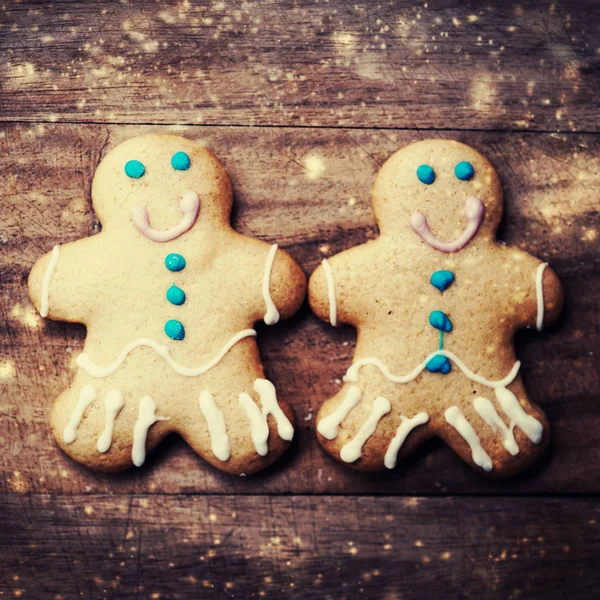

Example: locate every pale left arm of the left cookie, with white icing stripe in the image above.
[27,236,96,323]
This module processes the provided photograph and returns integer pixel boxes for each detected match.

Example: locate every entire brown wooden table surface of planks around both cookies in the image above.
[0,0,600,599]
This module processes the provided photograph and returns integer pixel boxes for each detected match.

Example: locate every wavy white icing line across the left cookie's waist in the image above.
[77,329,256,377]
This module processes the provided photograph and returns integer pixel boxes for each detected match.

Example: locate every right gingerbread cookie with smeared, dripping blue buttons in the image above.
[309,140,563,475]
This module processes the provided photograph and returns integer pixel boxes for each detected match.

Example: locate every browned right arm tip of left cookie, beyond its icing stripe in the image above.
[263,247,306,324]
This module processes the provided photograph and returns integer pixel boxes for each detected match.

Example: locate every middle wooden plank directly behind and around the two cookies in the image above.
[0,124,600,494]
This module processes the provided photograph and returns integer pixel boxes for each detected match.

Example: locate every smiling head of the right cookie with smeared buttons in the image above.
[373,140,503,252]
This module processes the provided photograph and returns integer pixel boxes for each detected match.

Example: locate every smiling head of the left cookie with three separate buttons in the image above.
[92,134,233,243]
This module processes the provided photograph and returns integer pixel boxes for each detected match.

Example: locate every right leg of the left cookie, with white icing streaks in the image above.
[178,378,294,475]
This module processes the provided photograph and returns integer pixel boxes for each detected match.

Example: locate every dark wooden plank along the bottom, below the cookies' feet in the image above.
[0,495,600,600]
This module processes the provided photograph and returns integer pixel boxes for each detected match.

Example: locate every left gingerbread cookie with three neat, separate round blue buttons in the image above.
[29,135,306,474]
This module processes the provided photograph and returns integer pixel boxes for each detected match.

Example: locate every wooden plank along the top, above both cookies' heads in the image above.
[0,0,600,131]
